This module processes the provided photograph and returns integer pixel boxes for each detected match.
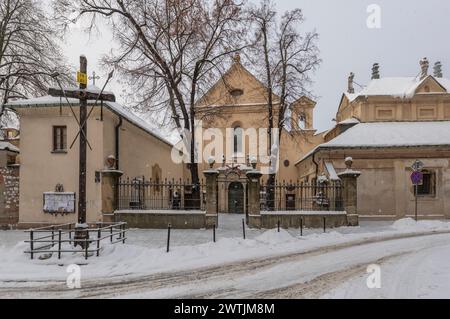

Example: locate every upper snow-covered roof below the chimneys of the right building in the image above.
[344,75,450,102]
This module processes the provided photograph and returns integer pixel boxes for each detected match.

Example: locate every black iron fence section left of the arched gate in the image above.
[117,177,206,210]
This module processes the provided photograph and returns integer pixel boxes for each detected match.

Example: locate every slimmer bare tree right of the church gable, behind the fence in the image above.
[249,0,321,208]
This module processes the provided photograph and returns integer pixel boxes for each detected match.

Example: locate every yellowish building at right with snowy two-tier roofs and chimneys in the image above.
[295,58,450,219]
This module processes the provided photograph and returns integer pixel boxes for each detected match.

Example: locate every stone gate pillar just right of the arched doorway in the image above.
[247,170,262,228]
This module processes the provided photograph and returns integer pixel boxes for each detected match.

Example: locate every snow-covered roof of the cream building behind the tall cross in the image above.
[6,92,173,146]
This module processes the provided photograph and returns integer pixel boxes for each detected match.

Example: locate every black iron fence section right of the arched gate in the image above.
[261,181,344,211]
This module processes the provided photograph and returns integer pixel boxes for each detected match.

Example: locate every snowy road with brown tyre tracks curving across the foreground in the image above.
[0,232,450,298]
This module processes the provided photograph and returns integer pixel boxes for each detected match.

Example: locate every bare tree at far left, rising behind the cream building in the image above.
[0,0,68,130]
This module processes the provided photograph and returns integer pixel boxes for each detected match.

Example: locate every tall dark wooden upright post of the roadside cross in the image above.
[78,56,87,225]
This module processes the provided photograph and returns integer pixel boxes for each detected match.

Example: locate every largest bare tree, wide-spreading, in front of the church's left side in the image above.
[55,0,250,206]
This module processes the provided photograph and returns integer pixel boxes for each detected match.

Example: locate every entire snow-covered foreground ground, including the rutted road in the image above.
[0,215,450,298]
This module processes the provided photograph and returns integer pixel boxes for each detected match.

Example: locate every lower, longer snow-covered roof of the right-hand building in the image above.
[297,121,450,164]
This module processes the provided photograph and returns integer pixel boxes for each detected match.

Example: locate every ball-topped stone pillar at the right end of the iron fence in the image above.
[338,157,361,226]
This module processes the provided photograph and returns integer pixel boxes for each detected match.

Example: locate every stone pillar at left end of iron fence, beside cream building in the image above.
[100,169,123,222]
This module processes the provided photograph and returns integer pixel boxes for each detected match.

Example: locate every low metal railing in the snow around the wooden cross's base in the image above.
[25,223,127,259]
